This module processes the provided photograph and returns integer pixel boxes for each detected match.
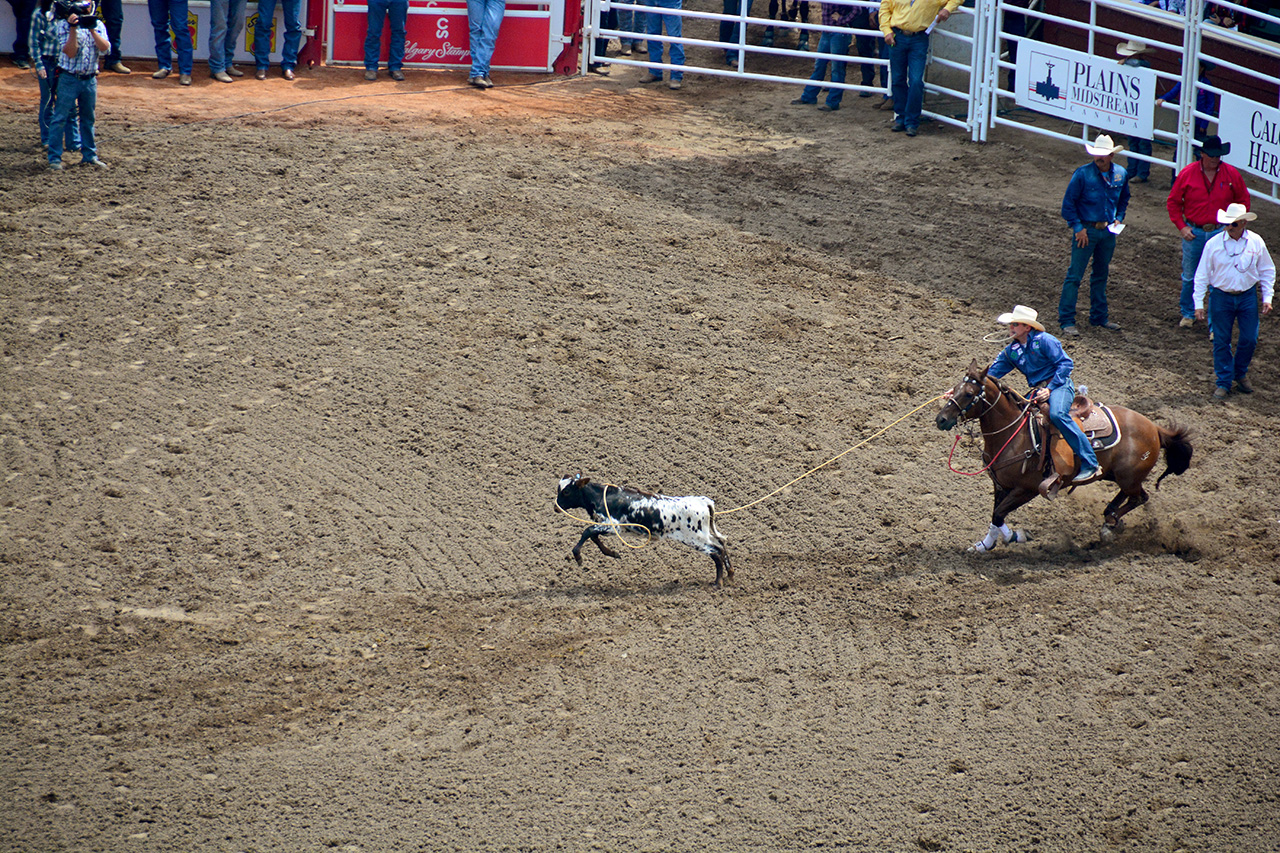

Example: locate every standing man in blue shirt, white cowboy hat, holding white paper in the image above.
[1057,134,1129,336]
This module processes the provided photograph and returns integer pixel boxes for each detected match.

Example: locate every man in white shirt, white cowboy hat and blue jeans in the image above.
[1193,202,1276,400]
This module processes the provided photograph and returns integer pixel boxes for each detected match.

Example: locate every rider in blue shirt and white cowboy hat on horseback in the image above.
[987,305,1098,483]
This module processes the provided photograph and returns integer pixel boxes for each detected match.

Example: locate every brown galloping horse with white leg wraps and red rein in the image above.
[937,361,1192,551]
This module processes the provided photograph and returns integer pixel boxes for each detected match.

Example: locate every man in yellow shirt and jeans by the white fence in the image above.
[881,0,960,136]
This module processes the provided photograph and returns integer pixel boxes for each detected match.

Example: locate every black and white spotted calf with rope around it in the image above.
[556,474,733,587]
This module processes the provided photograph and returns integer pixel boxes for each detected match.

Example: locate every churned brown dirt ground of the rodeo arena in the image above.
[0,38,1280,853]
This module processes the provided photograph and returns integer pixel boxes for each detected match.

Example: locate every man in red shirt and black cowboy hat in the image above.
[1165,136,1249,329]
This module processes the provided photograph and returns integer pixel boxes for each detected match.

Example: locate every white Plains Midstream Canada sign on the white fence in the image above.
[1014,41,1156,142]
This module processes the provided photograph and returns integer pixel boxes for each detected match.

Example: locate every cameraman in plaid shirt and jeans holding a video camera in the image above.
[49,0,111,172]
